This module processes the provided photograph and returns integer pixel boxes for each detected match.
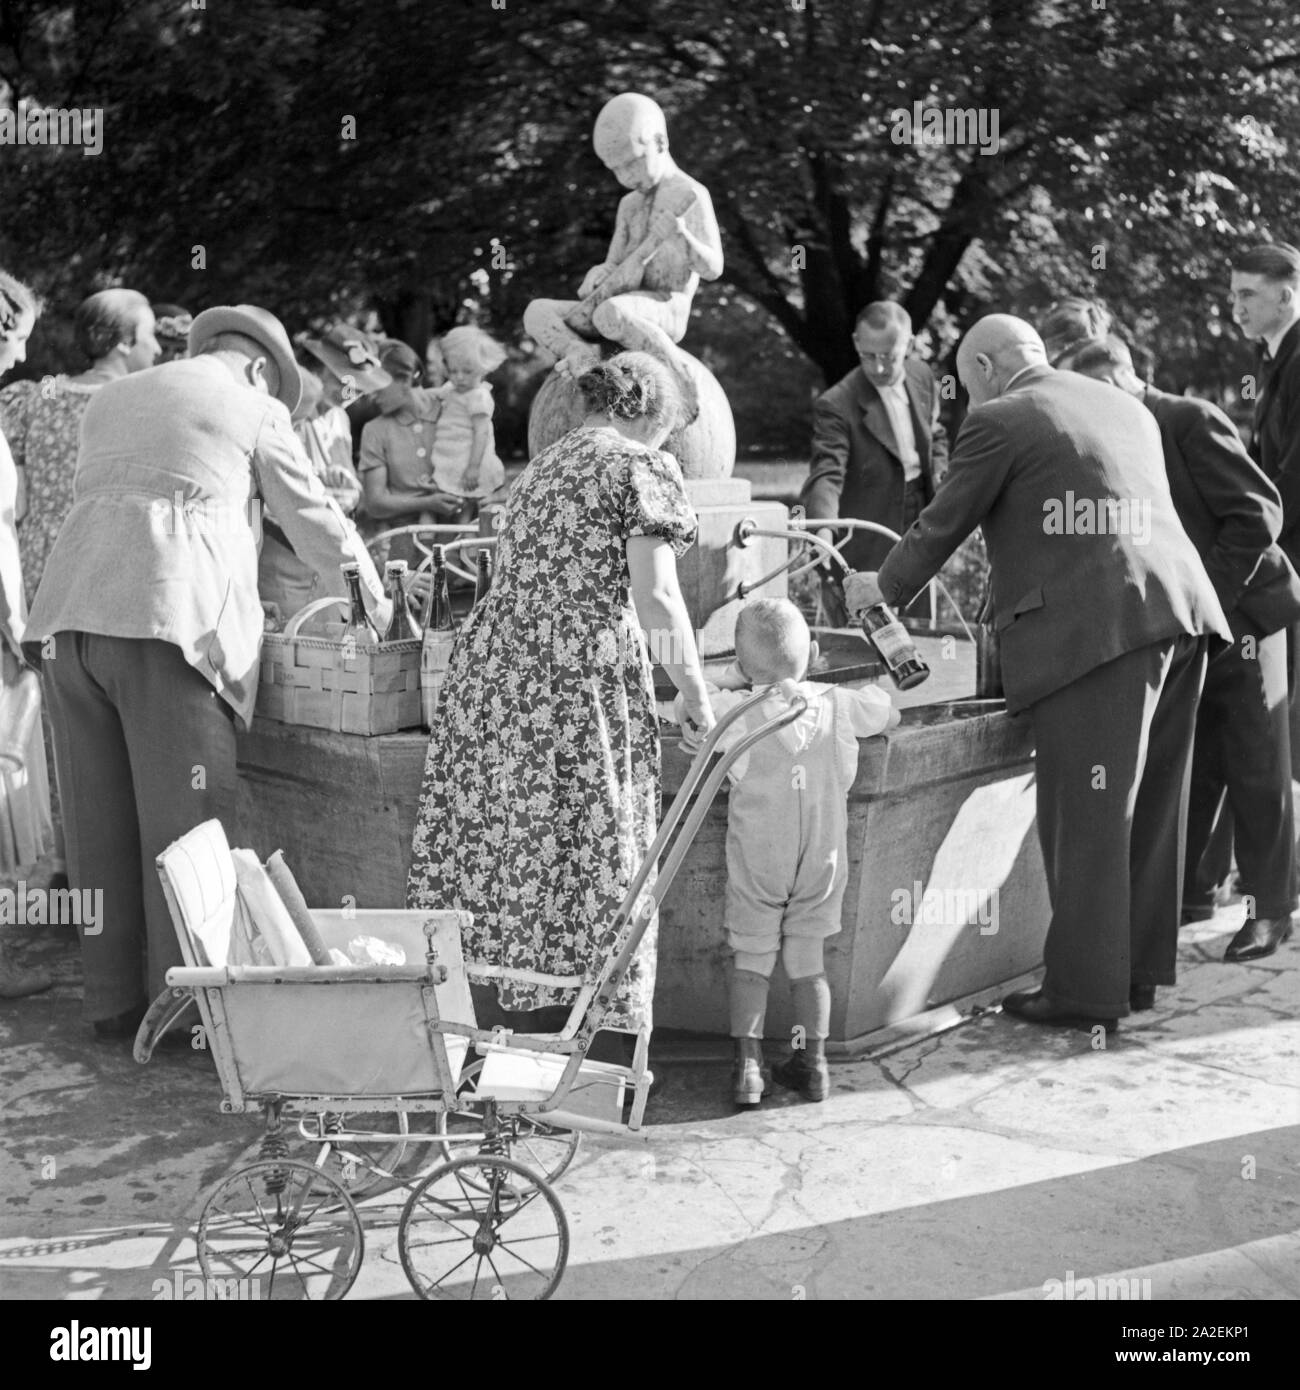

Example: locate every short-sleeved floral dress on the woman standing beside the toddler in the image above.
[407,427,695,1031]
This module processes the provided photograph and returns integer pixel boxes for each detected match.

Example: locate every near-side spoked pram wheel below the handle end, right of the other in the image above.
[398,1154,569,1300]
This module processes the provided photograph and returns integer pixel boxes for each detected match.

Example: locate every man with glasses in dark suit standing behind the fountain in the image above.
[799,300,948,627]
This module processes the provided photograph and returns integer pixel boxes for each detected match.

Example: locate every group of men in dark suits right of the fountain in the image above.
[823,243,1300,1030]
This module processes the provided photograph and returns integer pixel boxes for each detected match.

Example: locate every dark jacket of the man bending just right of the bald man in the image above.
[1143,386,1300,637]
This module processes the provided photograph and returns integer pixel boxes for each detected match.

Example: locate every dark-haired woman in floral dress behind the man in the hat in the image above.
[0,289,159,603]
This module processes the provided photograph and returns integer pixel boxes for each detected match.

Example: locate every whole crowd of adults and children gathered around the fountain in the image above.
[0,236,1300,1105]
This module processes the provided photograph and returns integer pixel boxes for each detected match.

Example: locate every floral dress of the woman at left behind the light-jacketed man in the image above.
[0,377,100,606]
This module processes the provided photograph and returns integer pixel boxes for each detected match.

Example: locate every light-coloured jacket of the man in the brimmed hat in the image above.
[26,357,382,727]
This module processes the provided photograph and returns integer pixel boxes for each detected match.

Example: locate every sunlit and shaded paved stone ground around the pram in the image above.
[0,889,1300,1300]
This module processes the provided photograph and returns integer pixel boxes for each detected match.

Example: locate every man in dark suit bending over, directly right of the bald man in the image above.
[1072,338,1300,960]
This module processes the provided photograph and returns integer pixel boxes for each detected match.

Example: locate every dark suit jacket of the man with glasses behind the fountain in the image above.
[799,357,948,570]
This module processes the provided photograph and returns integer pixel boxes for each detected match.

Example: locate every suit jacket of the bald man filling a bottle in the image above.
[880,366,1232,712]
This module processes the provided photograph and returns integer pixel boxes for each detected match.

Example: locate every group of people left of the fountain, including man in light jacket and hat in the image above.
[0,284,505,1011]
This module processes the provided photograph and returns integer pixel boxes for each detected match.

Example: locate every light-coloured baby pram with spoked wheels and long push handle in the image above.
[135,695,805,1298]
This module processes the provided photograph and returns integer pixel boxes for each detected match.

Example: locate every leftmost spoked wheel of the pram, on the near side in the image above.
[196,1158,364,1300]
